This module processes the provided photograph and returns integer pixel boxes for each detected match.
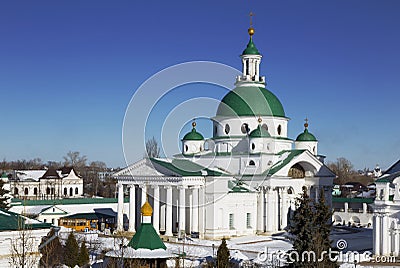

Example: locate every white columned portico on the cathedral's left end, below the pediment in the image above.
[117,176,204,236]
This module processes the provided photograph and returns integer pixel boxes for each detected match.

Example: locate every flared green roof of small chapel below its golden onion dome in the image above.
[128,223,167,250]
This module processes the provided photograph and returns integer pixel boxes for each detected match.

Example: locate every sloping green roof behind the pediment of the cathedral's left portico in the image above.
[150,158,224,176]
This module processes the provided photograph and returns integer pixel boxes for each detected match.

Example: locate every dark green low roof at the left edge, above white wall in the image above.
[0,209,52,231]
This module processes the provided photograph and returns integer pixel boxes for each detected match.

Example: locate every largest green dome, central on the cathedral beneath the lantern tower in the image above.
[217,86,285,117]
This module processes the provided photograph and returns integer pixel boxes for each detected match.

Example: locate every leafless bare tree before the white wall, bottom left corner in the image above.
[9,217,39,268]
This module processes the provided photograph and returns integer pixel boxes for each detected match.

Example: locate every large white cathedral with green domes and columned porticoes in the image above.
[114,27,335,239]
